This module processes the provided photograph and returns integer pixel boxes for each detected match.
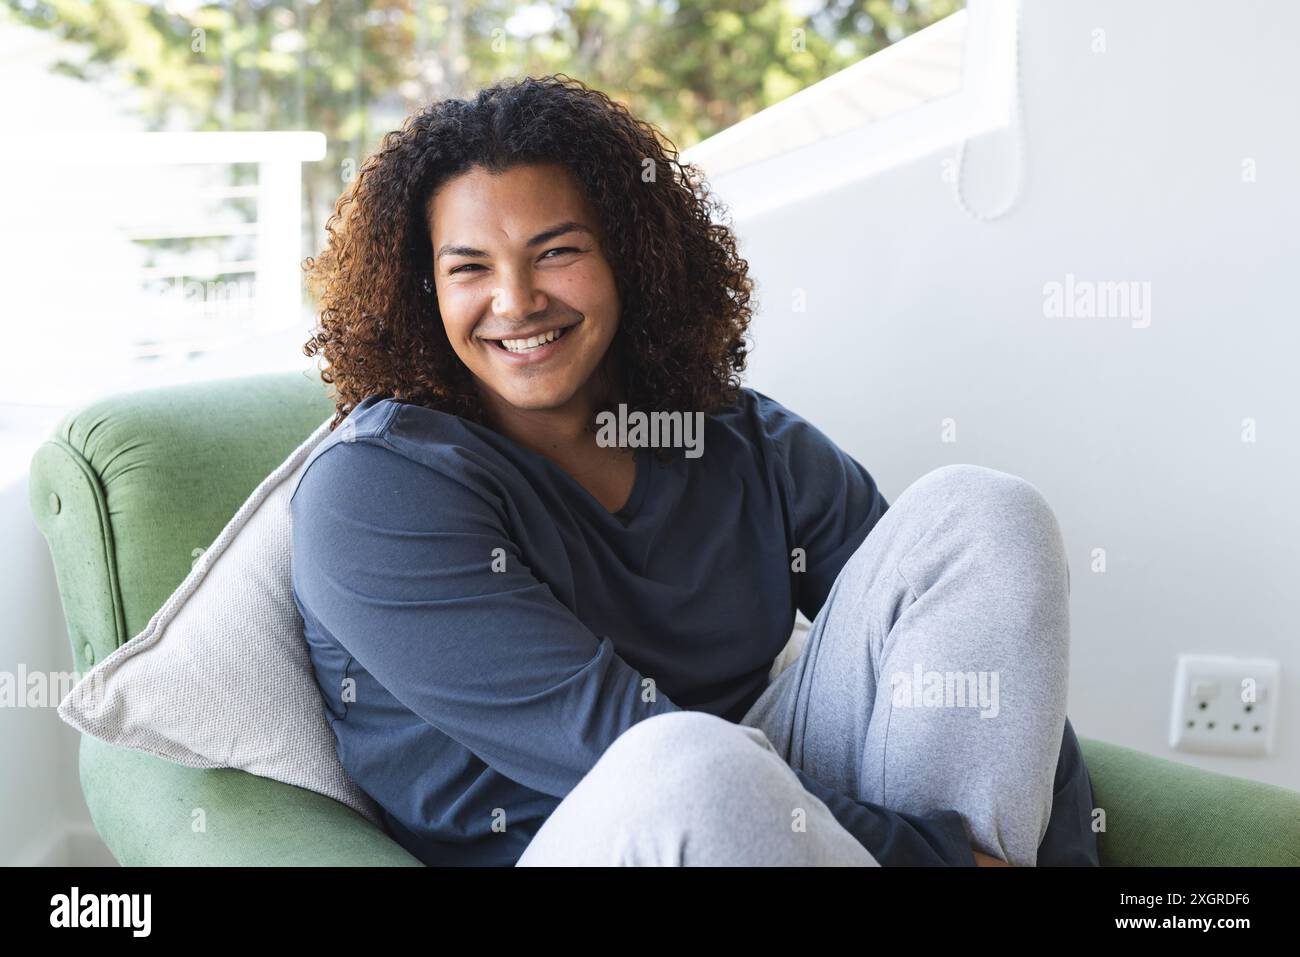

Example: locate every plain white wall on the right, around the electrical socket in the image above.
[712,0,1300,789]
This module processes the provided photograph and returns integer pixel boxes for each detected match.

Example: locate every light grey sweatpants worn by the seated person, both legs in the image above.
[517,465,1095,866]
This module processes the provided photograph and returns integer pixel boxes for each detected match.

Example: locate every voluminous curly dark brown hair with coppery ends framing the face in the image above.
[303,73,753,442]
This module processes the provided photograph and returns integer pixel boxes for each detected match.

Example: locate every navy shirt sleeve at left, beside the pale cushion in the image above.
[291,437,677,797]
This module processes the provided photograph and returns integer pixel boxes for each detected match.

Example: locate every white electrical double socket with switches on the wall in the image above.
[1169,654,1282,754]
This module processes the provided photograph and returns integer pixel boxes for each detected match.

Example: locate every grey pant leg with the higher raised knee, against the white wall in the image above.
[741,465,1086,866]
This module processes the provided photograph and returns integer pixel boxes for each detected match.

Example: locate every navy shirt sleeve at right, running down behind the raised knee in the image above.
[751,390,889,622]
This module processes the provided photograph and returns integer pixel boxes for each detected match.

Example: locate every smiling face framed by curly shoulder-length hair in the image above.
[428,164,619,417]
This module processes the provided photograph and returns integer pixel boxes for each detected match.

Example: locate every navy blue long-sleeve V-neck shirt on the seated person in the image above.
[291,389,974,866]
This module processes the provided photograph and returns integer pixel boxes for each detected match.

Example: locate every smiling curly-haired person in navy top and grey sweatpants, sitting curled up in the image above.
[293,78,1097,866]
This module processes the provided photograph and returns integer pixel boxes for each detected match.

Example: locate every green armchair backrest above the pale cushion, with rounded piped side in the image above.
[30,373,334,674]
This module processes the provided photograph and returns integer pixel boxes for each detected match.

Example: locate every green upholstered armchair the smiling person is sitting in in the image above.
[30,372,1300,866]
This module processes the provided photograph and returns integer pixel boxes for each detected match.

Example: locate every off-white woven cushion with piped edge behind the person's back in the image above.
[59,416,381,823]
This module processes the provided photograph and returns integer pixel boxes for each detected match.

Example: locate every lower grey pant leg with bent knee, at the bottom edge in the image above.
[516,711,878,867]
